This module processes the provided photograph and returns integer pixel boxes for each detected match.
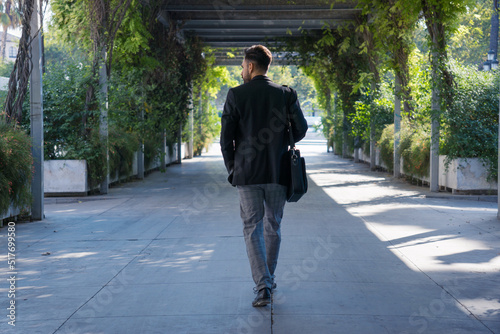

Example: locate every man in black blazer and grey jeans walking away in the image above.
[220,45,307,307]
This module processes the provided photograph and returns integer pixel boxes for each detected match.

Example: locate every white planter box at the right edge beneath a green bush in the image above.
[439,155,498,192]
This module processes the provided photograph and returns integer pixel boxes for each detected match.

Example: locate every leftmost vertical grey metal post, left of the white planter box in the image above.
[30,1,44,220]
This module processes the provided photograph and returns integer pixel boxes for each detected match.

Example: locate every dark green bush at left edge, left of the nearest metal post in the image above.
[0,121,33,214]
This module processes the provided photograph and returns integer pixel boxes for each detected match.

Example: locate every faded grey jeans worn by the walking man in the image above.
[238,184,286,291]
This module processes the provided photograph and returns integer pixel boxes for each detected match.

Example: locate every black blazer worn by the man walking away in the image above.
[220,75,307,186]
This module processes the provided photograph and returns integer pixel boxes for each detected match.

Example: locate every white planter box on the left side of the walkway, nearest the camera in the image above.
[43,160,89,196]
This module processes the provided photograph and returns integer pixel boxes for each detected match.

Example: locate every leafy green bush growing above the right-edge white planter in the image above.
[440,64,500,178]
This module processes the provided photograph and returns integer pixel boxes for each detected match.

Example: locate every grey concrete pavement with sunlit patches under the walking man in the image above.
[0,135,500,334]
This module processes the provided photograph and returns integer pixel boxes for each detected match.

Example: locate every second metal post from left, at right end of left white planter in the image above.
[99,47,110,194]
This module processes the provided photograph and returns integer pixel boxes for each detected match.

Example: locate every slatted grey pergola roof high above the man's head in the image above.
[158,0,361,65]
